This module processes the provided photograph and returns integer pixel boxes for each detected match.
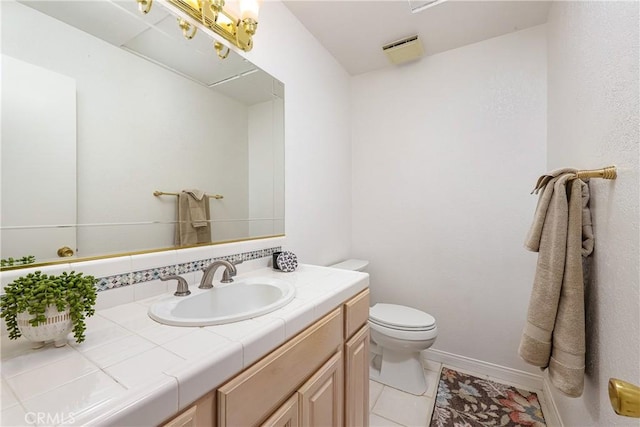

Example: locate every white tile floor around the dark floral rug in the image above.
[369,361,546,427]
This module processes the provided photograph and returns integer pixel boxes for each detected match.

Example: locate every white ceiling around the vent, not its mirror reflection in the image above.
[284,0,550,75]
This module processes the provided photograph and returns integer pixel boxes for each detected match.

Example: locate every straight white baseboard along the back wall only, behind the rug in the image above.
[422,348,543,391]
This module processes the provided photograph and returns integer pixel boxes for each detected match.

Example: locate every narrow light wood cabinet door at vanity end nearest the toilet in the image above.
[344,325,369,427]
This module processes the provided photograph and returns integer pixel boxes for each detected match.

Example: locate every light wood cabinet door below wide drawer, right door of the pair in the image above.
[298,351,344,427]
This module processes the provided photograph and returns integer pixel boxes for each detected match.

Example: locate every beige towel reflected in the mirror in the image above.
[175,190,211,246]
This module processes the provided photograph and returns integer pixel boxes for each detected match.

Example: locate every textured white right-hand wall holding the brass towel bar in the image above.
[547,1,640,426]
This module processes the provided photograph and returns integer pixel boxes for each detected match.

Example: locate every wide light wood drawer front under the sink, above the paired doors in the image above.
[218,308,343,427]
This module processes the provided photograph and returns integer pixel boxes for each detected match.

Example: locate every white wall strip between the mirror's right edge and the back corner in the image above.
[243,1,351,265]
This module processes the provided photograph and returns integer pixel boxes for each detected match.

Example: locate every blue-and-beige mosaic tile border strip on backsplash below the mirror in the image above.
[96,246,282,292]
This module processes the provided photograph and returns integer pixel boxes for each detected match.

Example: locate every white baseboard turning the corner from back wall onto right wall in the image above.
[421,348,564,427]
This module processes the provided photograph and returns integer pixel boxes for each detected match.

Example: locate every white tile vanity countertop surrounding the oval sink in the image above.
[0,265,369,426]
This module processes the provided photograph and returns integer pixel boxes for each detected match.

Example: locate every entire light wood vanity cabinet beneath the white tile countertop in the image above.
[163,289,369,427]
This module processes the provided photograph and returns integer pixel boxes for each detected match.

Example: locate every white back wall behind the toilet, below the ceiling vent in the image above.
[352,26,546,372]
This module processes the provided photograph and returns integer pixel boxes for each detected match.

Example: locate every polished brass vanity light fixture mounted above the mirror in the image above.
[136,0,259,59]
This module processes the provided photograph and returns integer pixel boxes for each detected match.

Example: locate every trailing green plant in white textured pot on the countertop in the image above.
[0,271,97,348]
